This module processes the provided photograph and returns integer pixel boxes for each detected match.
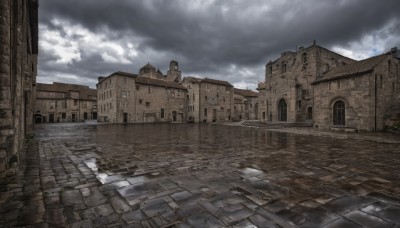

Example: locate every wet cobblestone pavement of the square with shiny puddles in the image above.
[0,124,400,227]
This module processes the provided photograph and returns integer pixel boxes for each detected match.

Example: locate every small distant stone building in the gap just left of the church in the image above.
[233,88,259,121]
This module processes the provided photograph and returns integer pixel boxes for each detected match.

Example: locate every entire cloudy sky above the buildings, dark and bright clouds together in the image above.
[37,0,400,89]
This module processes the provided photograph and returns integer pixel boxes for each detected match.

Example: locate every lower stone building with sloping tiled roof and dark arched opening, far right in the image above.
[312,48,400,131]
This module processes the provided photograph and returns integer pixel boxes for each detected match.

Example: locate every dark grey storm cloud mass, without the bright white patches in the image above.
[40,0,400,88]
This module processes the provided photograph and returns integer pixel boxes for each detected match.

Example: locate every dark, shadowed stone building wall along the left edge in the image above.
[0,0,38,179]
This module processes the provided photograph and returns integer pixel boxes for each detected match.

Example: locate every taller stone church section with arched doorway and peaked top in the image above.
[265,42,355,122]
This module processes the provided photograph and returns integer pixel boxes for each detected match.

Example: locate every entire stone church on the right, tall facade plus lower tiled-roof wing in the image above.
[265,42,400,131]
